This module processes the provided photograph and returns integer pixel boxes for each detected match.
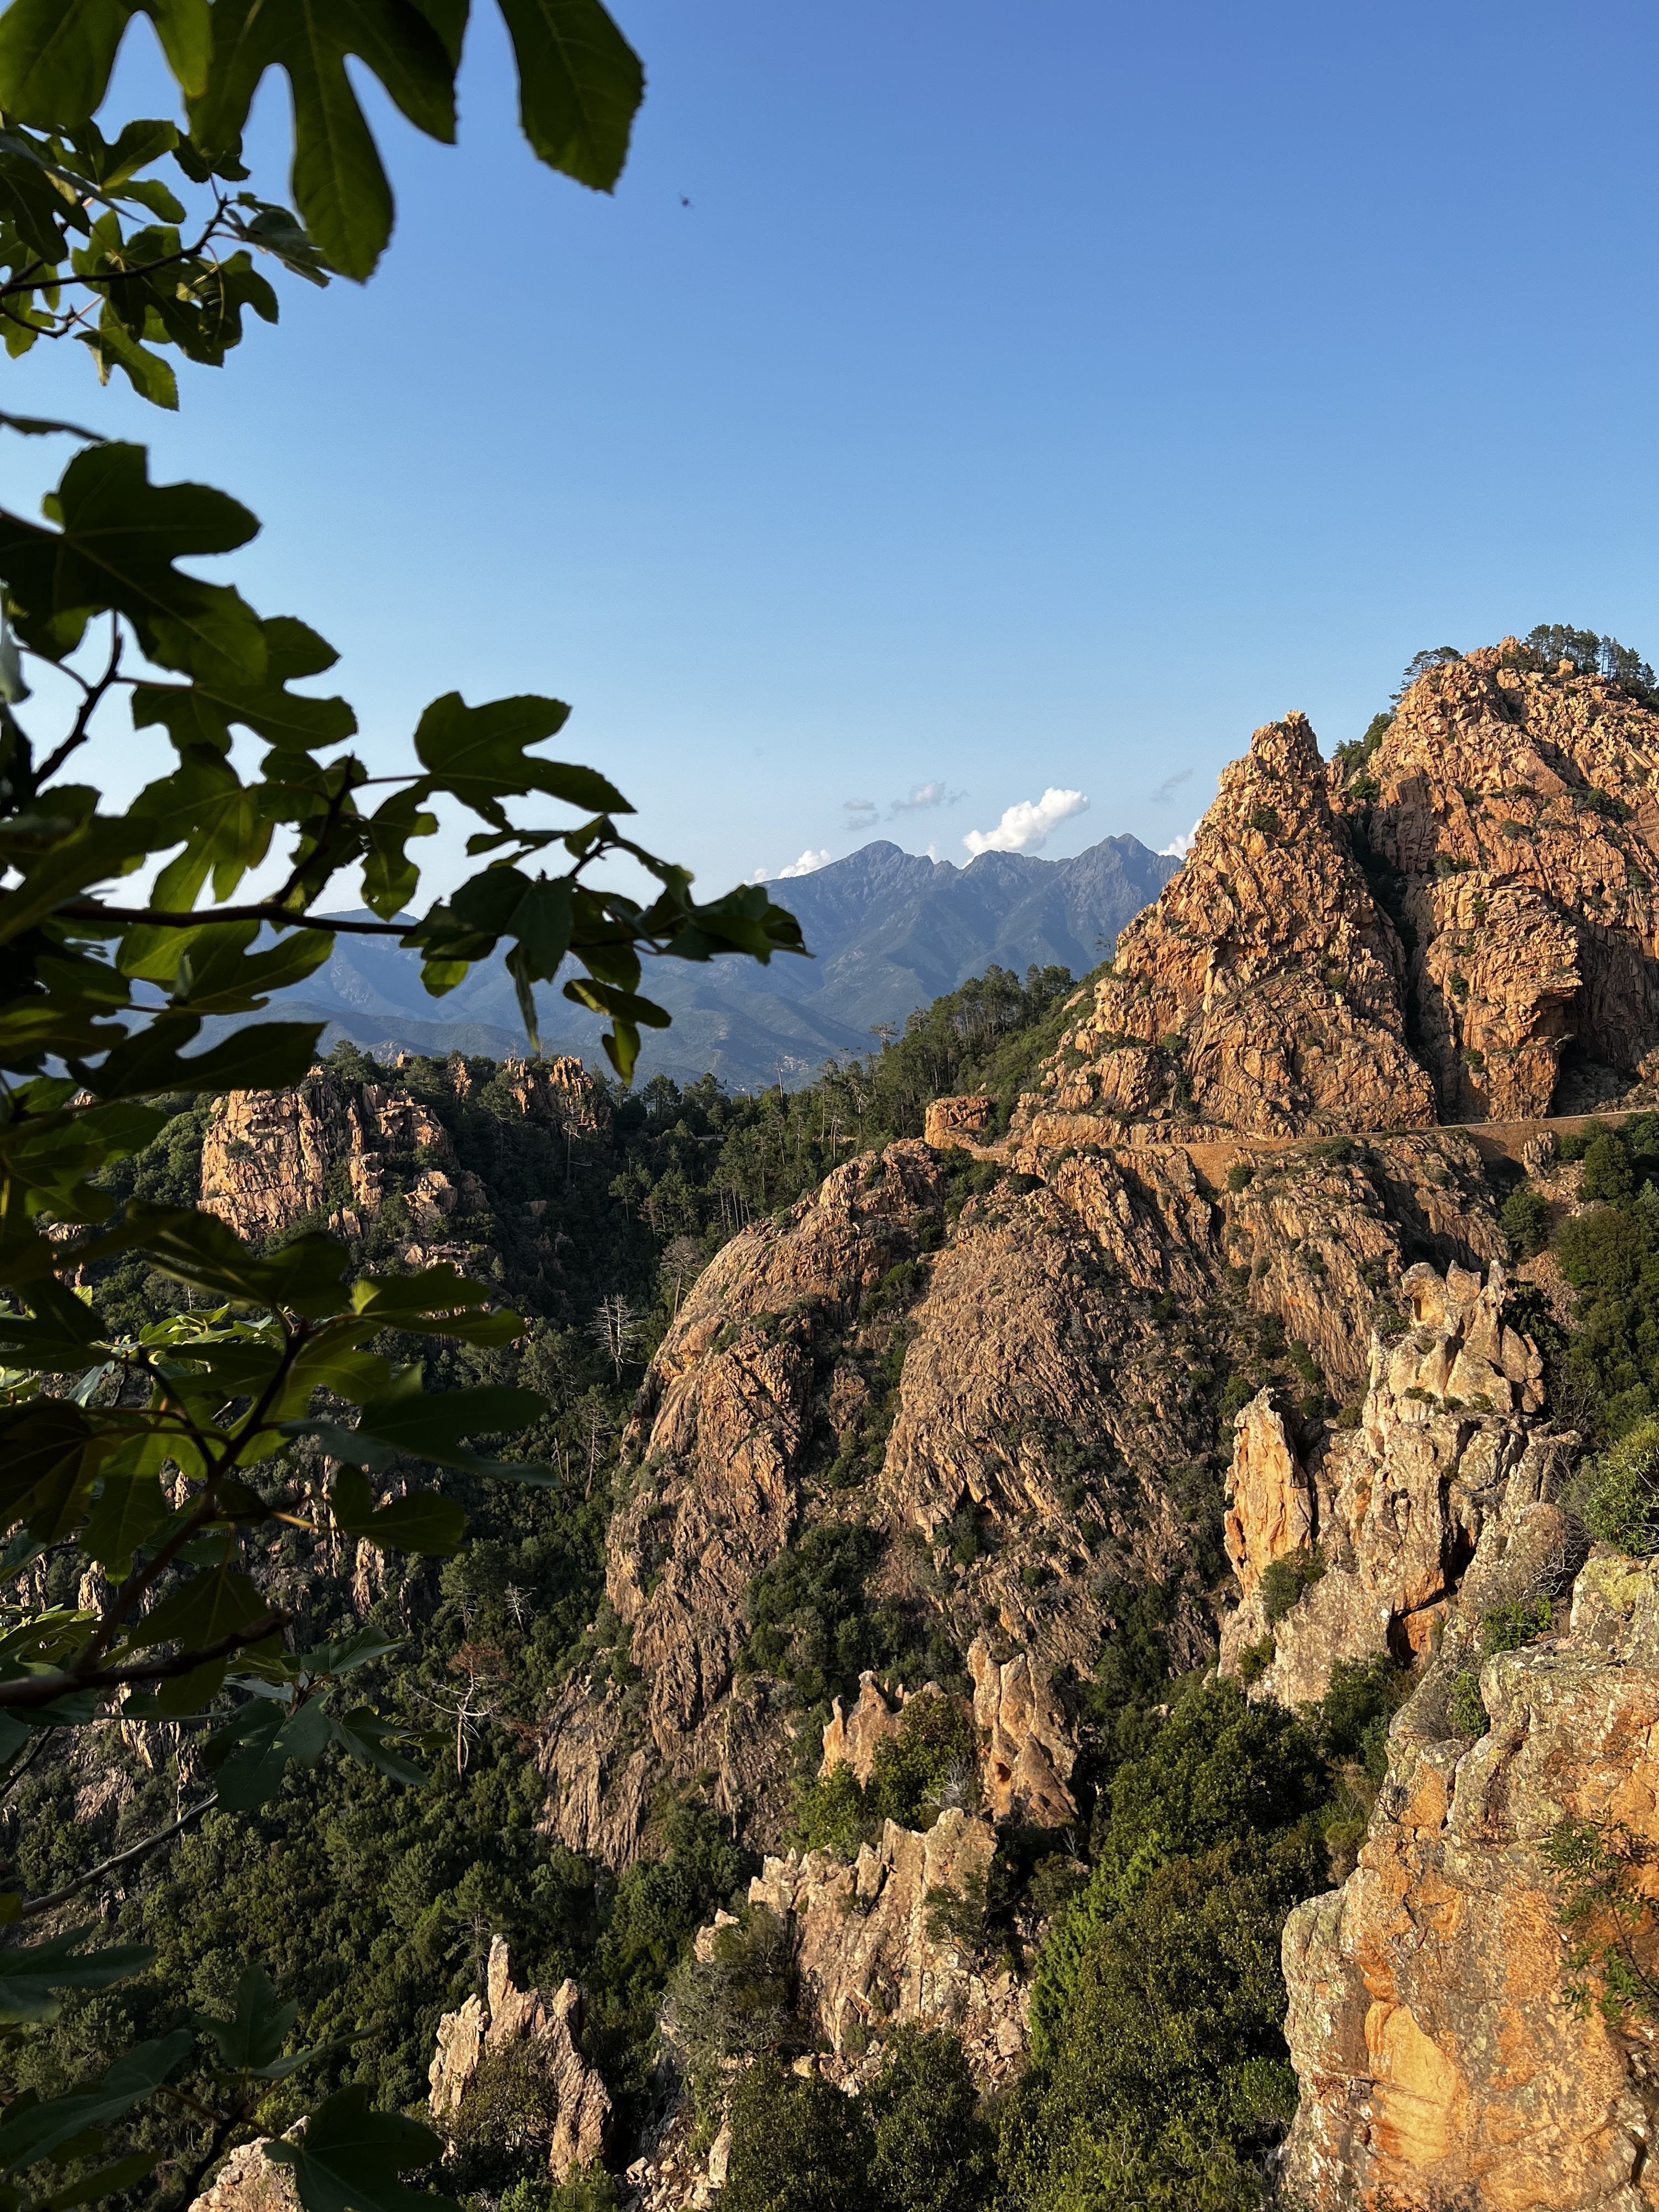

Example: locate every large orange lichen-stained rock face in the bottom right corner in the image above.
[1283,1540,1659,2212]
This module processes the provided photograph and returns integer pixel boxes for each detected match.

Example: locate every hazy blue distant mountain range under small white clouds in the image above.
[215,836,1181,1091]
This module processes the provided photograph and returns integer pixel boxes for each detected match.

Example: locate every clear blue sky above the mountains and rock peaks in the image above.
[7,0,1659,889]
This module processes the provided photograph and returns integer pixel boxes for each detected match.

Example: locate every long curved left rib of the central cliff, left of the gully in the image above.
[542,1144,940,1858]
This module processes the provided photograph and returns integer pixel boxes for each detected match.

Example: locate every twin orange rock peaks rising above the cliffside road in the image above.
[1018,641,1659,1144]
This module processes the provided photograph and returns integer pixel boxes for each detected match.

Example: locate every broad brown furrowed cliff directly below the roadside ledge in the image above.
[542,1106,1502,1865]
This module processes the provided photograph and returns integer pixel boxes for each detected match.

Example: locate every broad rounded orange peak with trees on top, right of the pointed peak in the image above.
[1363,639,1659,1121]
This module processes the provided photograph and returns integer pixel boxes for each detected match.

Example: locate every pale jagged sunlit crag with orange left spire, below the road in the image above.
[1221,1263,1571,1705]
